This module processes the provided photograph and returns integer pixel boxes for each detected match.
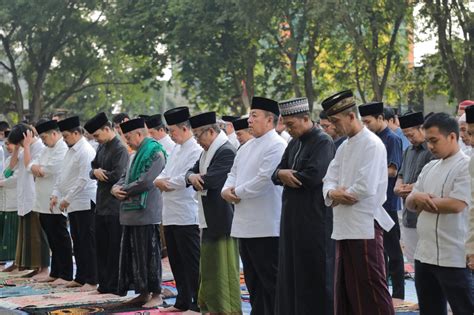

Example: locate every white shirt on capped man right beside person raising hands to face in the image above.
[28,139,68,214]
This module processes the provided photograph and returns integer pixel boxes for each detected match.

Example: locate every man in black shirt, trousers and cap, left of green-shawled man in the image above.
[84,113,128,293]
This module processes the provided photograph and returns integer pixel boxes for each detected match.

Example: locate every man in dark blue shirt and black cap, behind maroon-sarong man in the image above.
[359,102,405,306]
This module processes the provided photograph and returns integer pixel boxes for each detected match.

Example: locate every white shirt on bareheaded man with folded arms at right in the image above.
[413,150,471,268]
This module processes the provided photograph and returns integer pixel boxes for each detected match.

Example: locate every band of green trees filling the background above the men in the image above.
[0,0,466,118]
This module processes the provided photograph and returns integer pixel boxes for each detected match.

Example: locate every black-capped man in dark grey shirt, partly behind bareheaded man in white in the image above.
[394,112,434,264]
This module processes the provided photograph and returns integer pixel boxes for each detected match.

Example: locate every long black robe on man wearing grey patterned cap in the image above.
[272,128,335,315]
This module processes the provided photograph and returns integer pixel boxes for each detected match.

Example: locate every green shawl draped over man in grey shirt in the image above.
[121,138,166,211]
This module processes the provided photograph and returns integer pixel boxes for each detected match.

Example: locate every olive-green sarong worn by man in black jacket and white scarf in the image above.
[198,236,242,315]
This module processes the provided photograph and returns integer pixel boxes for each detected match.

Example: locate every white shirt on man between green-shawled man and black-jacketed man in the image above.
[157,137,202,225]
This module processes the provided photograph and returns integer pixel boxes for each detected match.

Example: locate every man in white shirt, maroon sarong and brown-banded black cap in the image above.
[322,91,395,315]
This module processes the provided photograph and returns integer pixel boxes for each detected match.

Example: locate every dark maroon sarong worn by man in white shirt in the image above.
[334,223,395,315]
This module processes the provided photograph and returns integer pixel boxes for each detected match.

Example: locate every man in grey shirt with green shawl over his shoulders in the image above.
[112,118,165,307]
